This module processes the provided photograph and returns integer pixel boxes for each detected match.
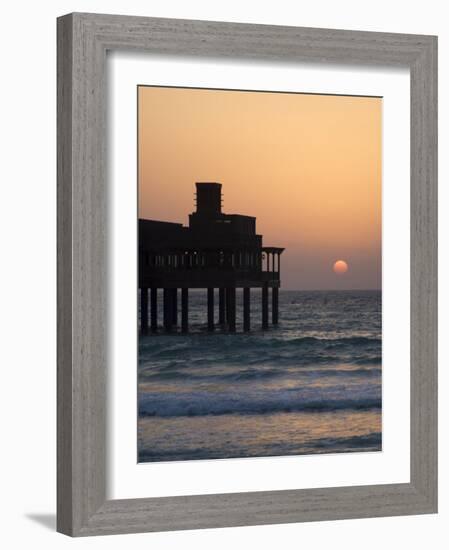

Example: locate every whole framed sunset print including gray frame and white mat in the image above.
[58,14,437,536]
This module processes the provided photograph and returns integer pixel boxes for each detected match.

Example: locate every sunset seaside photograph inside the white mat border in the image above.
[135,84,382,463]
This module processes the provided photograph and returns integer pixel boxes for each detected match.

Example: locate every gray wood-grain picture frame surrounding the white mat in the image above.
[57,13,437,536]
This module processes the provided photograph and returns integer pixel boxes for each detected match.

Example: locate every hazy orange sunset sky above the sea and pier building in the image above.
[138,86,382,290]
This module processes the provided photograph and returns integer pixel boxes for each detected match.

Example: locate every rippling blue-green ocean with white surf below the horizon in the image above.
[138,289,382,462]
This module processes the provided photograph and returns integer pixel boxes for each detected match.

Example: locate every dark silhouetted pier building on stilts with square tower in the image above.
[139,182,284,334]
